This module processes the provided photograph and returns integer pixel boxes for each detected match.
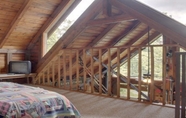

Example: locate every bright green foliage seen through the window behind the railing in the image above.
[120,37,163,80]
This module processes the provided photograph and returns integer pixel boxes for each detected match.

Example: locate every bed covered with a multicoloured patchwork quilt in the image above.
[0,82,80,118]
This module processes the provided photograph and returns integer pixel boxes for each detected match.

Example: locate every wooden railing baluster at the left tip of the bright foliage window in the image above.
[117,48,120,97]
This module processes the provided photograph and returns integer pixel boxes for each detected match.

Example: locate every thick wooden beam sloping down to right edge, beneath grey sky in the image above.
[110,0,186,45]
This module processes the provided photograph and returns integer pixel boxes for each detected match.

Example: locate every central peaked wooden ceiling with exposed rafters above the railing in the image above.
[37,0,160,72]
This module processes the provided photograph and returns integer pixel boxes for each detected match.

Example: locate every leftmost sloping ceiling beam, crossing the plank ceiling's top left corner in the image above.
[0,0,33,48]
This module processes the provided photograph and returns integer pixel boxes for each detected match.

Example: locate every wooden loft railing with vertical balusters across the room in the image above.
[34,45,180,105]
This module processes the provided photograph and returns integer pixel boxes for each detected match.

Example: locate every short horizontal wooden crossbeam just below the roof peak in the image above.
[87,14,136,27]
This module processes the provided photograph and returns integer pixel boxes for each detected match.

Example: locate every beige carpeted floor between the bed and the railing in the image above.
[32,85,175,118]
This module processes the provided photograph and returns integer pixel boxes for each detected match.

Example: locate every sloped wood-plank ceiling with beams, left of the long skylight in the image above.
[0,0,79,50]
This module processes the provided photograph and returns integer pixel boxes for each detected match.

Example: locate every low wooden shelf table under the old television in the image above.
[0,73,36,84]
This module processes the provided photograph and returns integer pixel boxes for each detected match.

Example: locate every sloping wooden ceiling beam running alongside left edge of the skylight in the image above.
[27,0,75,50]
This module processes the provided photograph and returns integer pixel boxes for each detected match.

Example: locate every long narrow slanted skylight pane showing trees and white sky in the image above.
[47,0,94,52]
